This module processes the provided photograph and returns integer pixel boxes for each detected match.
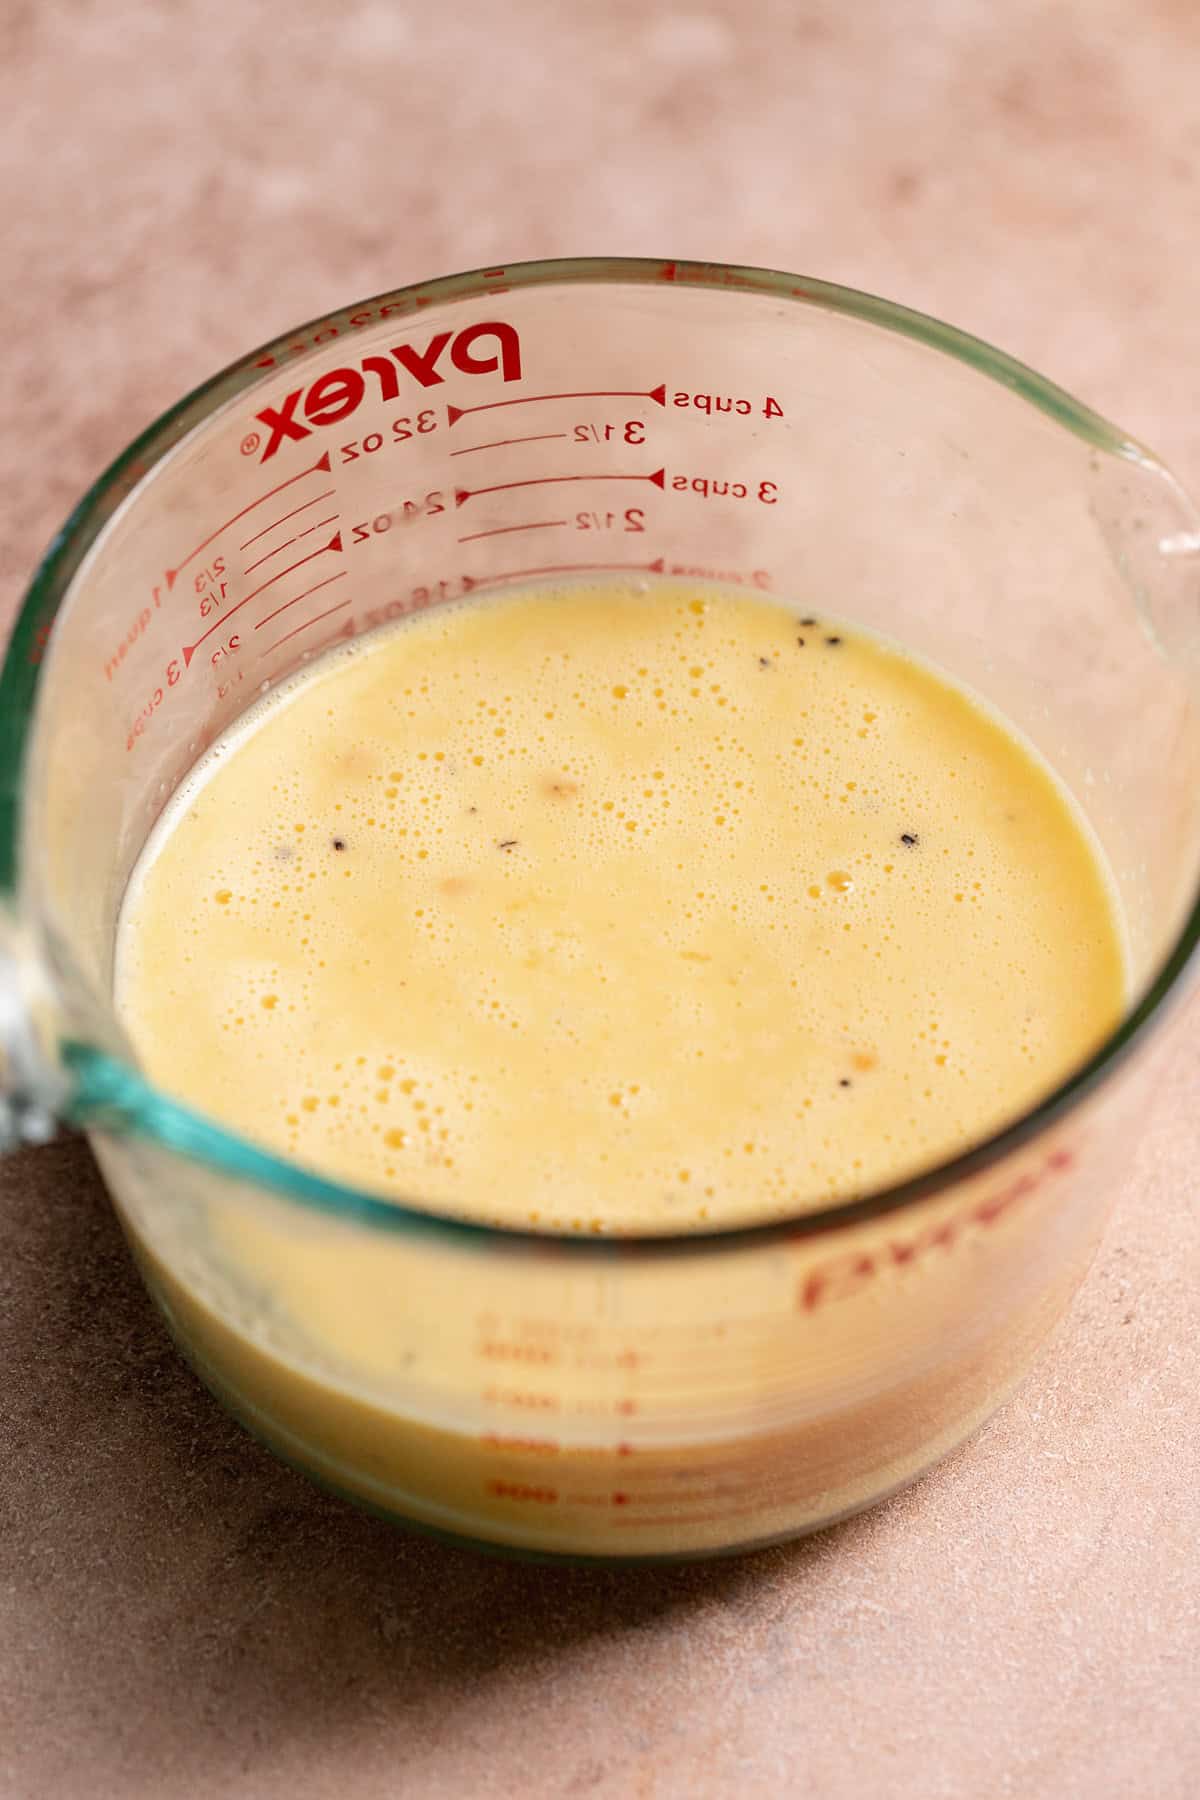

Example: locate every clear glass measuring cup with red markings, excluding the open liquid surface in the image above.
[0,261,1200,1559]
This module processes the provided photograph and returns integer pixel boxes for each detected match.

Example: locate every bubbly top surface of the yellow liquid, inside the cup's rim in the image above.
[117,585,1124,1231]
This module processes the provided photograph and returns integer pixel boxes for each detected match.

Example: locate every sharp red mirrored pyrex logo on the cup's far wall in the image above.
[254,319,520,463]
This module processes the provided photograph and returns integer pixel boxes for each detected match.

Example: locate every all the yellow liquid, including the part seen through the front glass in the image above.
[107,583,1124,1555]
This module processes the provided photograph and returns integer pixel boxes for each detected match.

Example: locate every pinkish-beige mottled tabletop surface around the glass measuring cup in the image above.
[0,0,1200,1800]
